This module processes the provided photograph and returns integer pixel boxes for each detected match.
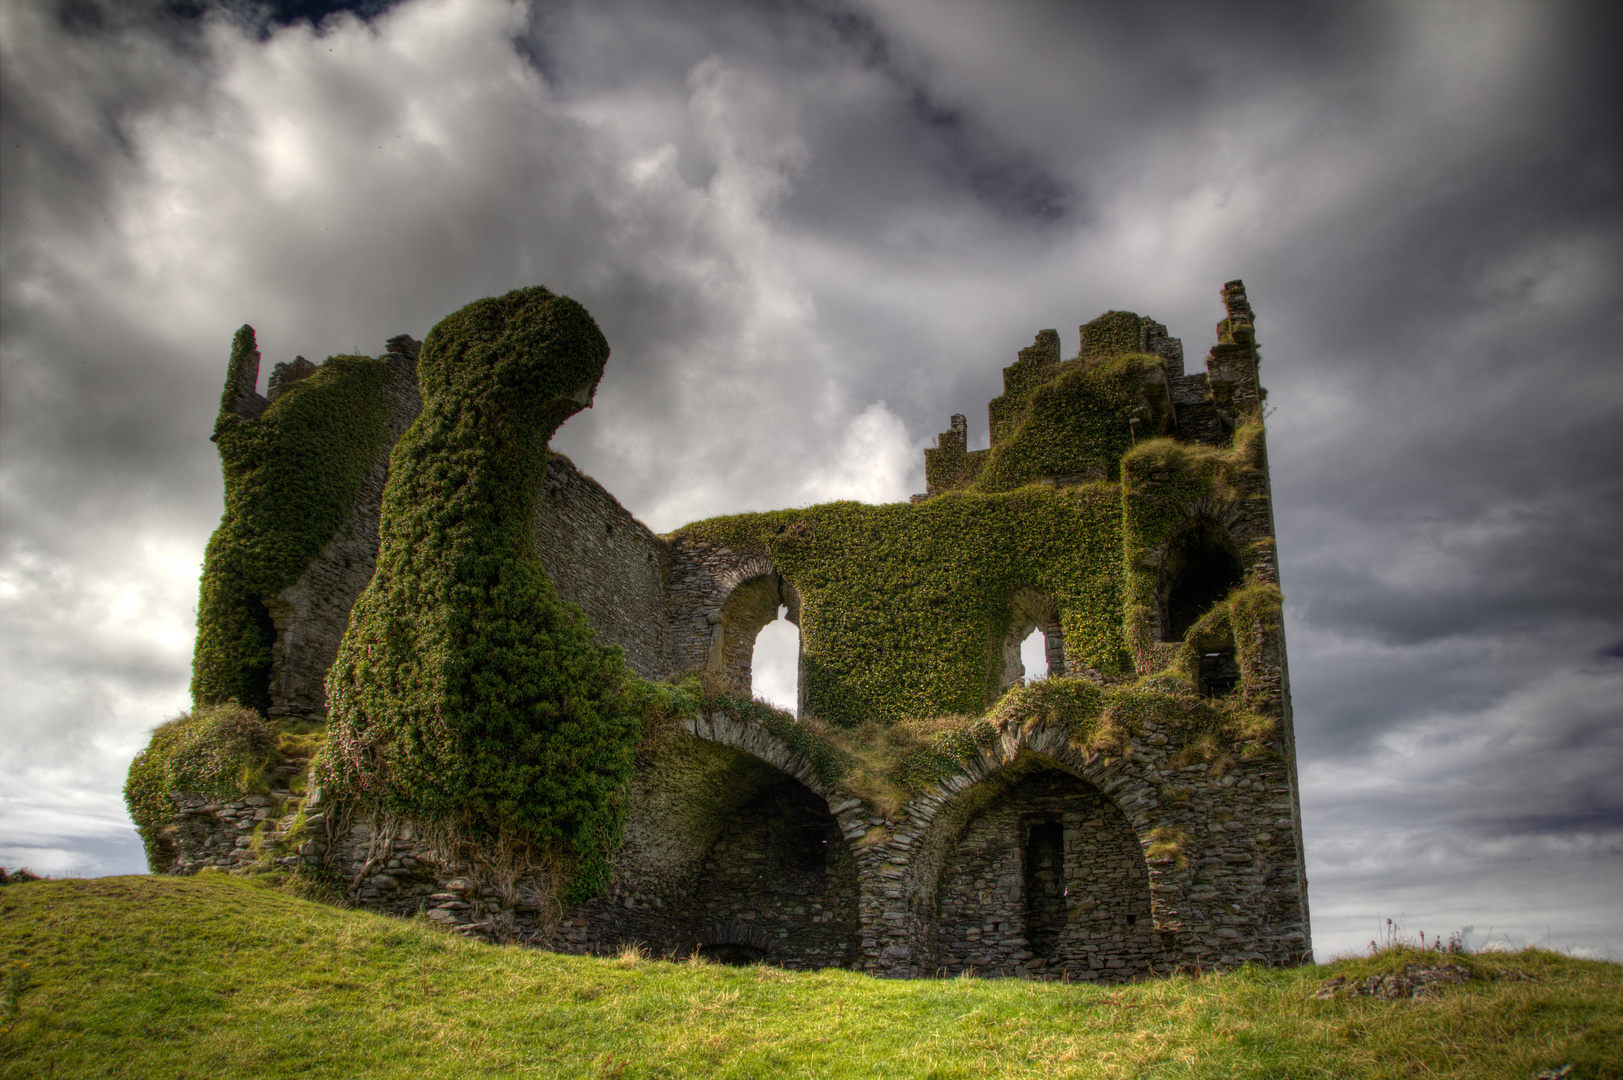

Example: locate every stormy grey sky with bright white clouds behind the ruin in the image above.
[0,0,1623,958]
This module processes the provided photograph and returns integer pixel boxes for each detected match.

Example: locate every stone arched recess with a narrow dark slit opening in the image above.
[935,768,1162,983]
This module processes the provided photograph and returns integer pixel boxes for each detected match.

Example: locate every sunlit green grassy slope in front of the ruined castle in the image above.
[0,875,1623,1080]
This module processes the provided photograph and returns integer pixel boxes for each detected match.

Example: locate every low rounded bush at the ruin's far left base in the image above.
[123,702,278,874]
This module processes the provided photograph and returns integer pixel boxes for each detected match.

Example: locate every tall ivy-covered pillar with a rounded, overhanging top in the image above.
[320,287,644,883]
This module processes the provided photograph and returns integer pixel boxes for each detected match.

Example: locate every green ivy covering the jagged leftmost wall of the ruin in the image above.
[192,326,388,711]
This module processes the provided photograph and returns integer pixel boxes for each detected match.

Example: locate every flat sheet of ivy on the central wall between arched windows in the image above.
[680,484,1130,728]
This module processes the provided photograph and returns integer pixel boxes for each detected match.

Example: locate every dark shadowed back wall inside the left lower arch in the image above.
[691,770,859,968]
